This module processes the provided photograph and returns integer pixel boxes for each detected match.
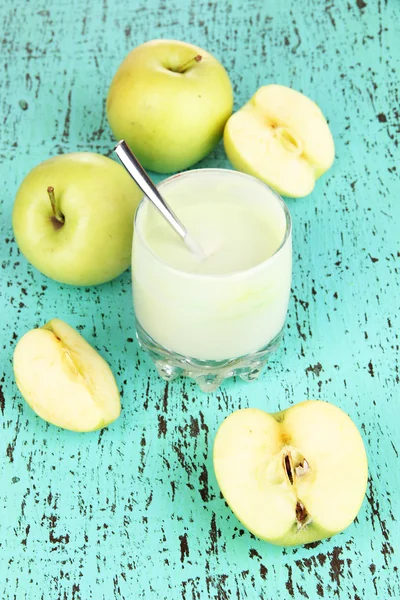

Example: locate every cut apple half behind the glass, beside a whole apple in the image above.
[224,85,335,198]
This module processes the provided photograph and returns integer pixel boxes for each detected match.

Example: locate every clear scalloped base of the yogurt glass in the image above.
[136,321,283,392]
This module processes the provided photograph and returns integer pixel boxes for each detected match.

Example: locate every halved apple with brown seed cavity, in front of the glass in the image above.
[214,400,368,546]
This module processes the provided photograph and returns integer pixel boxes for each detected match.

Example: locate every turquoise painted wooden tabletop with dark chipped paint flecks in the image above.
[0,0,400,600]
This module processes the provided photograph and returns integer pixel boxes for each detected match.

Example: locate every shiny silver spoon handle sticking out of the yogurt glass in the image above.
[114,140,187,240]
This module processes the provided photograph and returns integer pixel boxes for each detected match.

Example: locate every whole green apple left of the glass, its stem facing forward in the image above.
[12,152,143,285]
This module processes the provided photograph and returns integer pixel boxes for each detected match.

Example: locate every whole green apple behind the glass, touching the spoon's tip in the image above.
[107,40,233,173]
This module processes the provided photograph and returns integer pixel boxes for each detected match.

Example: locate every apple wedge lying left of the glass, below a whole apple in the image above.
[14,319,120,431]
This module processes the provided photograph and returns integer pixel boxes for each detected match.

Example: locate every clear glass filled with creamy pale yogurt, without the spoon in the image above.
[132,169,292,391]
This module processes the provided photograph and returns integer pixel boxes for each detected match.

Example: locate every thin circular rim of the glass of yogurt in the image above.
[132,167,292,279]
